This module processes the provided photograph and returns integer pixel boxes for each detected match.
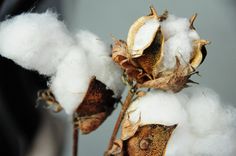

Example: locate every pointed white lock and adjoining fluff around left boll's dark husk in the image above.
[50,30,124,114]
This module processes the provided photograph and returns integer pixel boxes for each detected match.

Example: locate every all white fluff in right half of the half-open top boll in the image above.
[161,15,200,69]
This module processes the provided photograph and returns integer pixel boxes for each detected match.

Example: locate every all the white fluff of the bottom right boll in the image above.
[126,87,236,156]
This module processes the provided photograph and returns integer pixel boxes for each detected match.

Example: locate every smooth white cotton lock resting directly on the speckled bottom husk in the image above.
[127,91,186,125]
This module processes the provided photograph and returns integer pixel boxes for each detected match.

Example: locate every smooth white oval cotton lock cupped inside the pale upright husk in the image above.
[132,18,160,51]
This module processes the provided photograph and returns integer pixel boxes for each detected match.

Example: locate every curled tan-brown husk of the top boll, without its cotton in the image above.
[112,7,209,92]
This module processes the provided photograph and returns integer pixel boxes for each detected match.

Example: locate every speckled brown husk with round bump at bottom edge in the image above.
[124,124,177,156]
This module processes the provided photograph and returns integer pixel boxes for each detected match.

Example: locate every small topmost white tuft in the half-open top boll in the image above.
[161,15,190,40]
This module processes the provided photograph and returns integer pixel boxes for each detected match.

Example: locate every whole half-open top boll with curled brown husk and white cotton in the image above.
[112,7,209,92]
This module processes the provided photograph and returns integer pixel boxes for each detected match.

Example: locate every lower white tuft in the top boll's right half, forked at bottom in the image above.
[163,32,193,69]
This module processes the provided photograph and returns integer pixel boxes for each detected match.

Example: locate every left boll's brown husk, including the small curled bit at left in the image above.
[37,77,118,134]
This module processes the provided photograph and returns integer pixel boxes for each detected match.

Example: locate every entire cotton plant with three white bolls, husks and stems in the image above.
[0,7,236,156]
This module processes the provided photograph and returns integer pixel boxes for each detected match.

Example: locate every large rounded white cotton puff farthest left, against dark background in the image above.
[0,11,74,75]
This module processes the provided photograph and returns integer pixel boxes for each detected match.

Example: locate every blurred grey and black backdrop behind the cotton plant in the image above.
[0,0,236,156]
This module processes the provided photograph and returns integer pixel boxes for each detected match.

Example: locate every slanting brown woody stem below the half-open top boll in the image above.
[105,88,136,155]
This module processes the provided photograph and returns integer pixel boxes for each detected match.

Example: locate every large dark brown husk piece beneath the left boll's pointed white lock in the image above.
[75,77,117,134]
